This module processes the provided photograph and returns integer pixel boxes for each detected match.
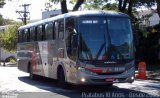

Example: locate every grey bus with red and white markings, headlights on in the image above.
[17,11,135,85]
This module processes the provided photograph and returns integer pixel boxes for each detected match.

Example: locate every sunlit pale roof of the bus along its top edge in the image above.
[18,10,129,30]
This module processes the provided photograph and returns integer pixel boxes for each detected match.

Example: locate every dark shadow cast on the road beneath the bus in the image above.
[18,77,158,98]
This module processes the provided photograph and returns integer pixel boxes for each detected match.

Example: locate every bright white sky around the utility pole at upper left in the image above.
[0,0,53,20]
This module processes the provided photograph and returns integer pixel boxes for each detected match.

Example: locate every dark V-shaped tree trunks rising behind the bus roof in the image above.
[50,0,85,14]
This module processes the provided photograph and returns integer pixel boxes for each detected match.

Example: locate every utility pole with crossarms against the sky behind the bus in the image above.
[16,4,31,25]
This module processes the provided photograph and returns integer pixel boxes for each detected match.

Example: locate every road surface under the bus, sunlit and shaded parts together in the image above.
[0,66,160,98]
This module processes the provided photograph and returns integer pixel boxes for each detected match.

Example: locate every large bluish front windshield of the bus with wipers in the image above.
[78,17,133,60]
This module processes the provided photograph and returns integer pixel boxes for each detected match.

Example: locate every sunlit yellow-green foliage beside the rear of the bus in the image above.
[0,23,22,52]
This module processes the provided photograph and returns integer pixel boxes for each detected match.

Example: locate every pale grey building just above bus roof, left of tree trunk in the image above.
[42,10,62,19]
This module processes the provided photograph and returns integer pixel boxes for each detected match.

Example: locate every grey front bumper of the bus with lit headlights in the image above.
[77,70,135,85]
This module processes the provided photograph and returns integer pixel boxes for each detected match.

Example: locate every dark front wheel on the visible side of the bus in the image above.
[58,68,66,88]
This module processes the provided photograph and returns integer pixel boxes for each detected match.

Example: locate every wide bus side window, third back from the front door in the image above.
[45,23,54,40]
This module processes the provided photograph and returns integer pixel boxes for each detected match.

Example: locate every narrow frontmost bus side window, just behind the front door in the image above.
[58,21,64,39]
